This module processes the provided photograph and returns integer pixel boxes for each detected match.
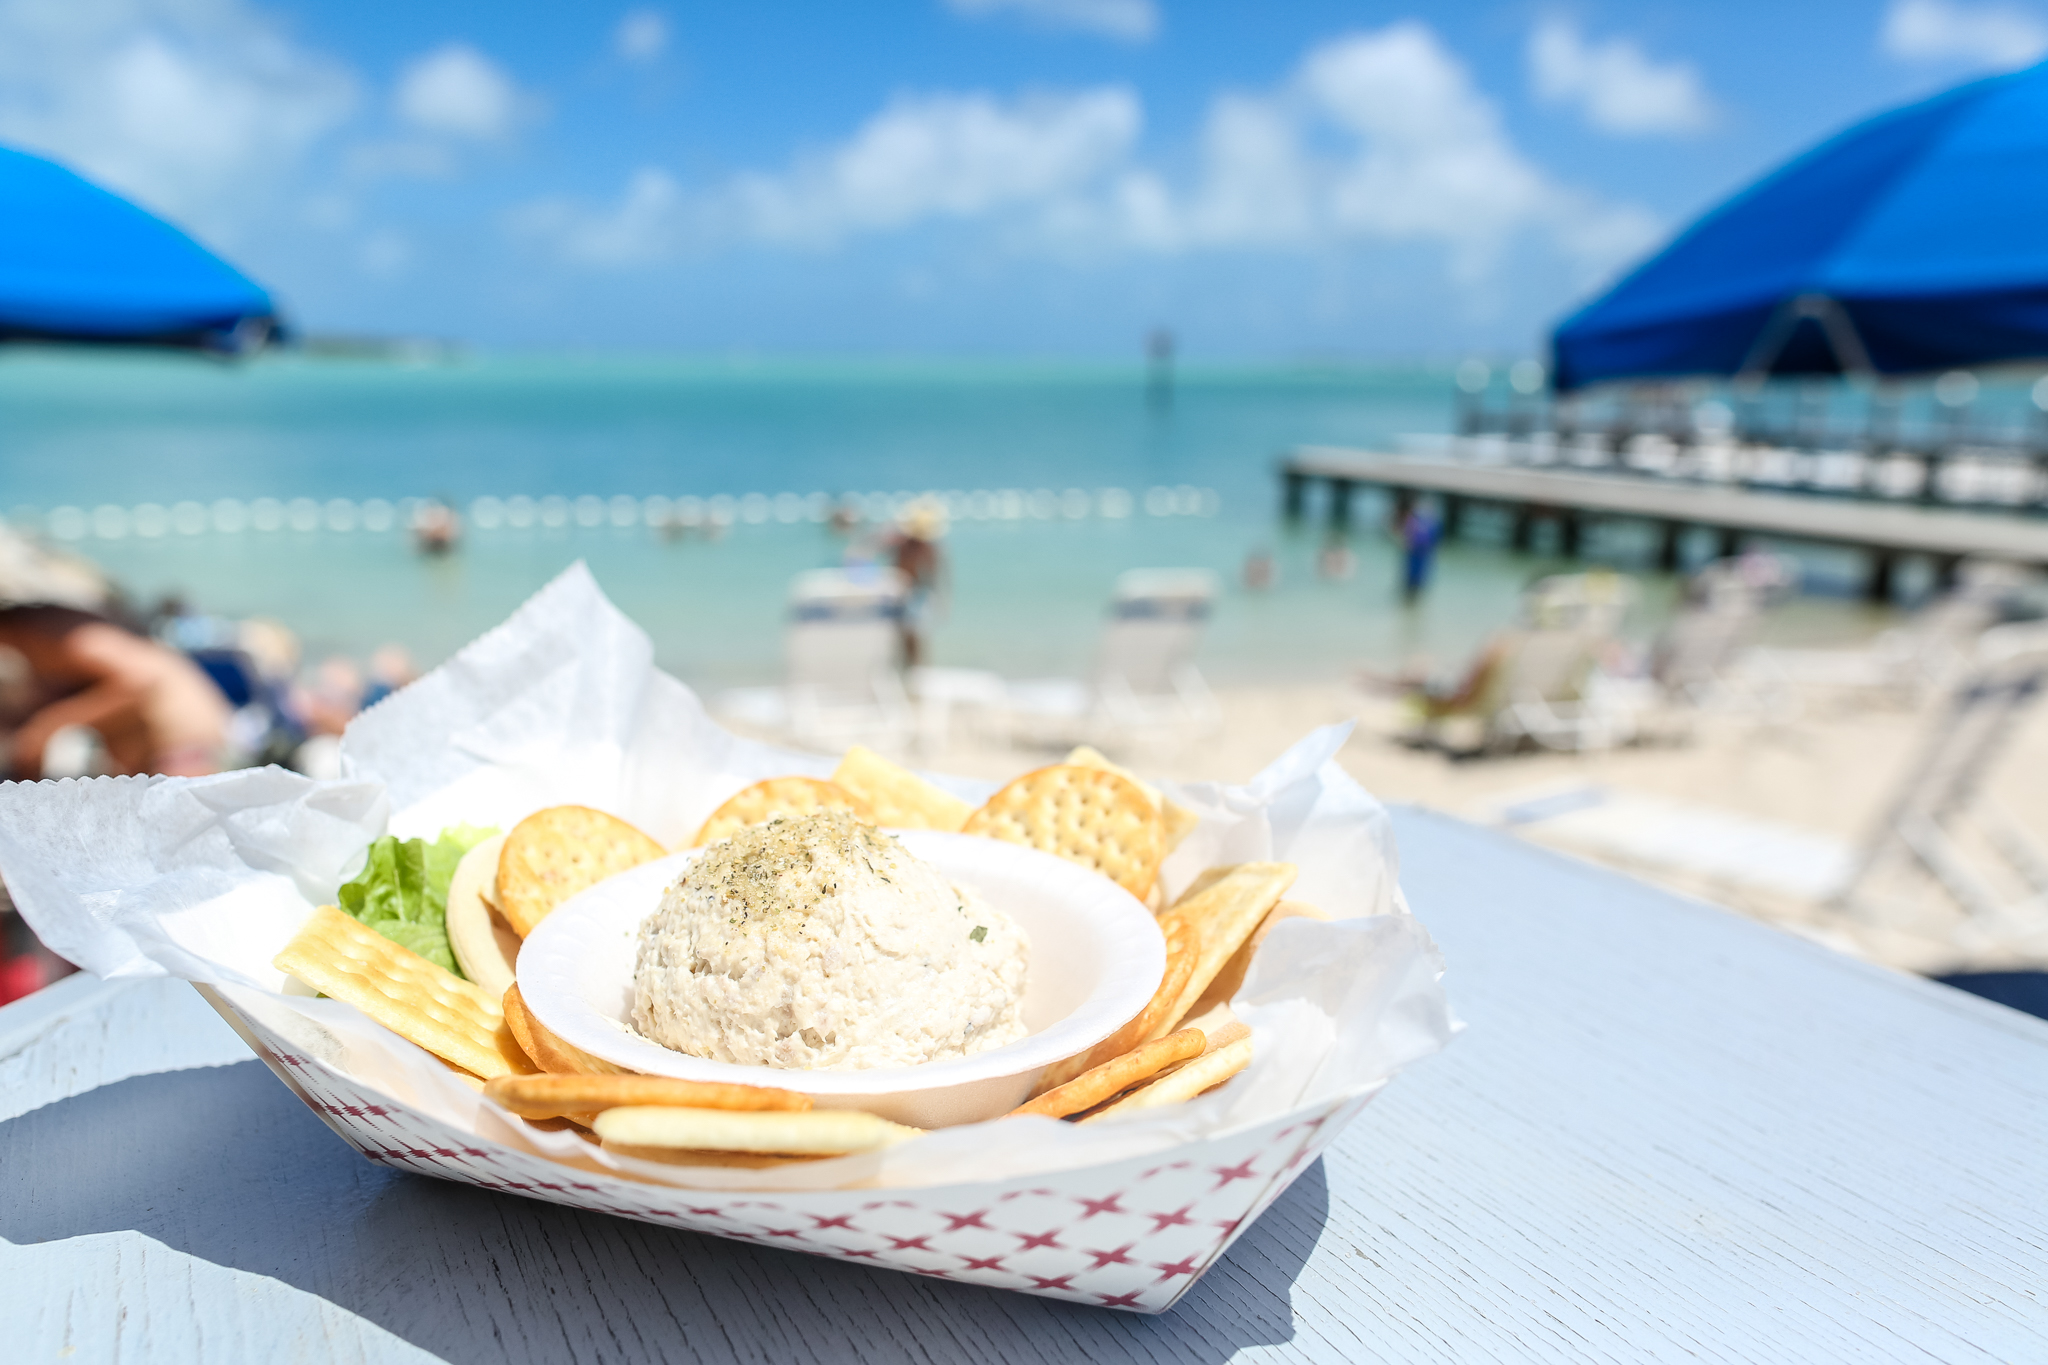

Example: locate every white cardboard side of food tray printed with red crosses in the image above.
[242,998,1368,1314]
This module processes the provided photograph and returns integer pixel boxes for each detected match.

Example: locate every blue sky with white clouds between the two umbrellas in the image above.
[0,0,2048,358]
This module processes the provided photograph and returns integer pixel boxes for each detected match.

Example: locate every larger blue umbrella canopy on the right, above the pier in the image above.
[1552,63,2048,391]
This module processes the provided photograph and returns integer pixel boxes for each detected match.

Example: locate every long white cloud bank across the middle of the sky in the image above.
[514,23,1659,282]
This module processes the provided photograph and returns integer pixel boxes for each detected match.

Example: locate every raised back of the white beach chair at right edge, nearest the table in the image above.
[1833,624,2048,948]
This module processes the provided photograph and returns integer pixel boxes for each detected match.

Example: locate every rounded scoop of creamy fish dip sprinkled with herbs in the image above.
[633,810,1028,1070]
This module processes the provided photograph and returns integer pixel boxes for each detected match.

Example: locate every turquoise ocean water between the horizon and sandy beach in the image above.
[0,352,1884,688]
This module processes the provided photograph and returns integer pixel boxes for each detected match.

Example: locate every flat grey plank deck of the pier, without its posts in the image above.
[1284,446,2048,565]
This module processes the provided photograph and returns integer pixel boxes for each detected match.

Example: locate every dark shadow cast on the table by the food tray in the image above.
[0,1062,1329,1365]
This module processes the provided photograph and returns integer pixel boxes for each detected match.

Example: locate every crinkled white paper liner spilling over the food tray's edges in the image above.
[0,565,1456,1191]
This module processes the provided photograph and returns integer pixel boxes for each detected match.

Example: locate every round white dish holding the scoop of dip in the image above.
[518,831,1165,1128]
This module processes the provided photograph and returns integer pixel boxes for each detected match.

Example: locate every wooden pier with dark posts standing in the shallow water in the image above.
[1280,446,2048,602]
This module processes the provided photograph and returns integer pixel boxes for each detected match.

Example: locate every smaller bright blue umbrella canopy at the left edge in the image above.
[0,147,276,350]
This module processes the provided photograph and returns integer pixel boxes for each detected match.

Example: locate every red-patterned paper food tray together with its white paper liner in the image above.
[0,565,1456,1312]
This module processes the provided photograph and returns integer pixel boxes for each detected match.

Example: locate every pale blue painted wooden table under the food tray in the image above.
[0,810,2048,1363]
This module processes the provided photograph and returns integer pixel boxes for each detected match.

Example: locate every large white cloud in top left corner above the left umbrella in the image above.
[0,0,356,239]
